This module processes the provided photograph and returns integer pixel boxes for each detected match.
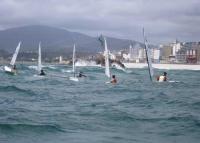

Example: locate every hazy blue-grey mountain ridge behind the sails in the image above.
[0,26,144,54]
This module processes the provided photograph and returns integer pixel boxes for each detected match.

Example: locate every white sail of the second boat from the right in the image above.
[104,38,110,78]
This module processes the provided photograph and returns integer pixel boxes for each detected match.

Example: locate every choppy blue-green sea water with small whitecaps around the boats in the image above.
[0,65,200,143]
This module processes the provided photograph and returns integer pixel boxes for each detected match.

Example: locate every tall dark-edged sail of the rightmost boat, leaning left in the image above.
[143,29,154,81]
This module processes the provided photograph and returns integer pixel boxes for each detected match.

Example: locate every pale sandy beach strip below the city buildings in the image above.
[123,63,200,70]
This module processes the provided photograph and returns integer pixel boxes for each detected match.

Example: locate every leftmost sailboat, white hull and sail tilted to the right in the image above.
[4,42,21,74]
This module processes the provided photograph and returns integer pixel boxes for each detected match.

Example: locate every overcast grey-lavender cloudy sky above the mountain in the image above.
[0,0,200,44]
